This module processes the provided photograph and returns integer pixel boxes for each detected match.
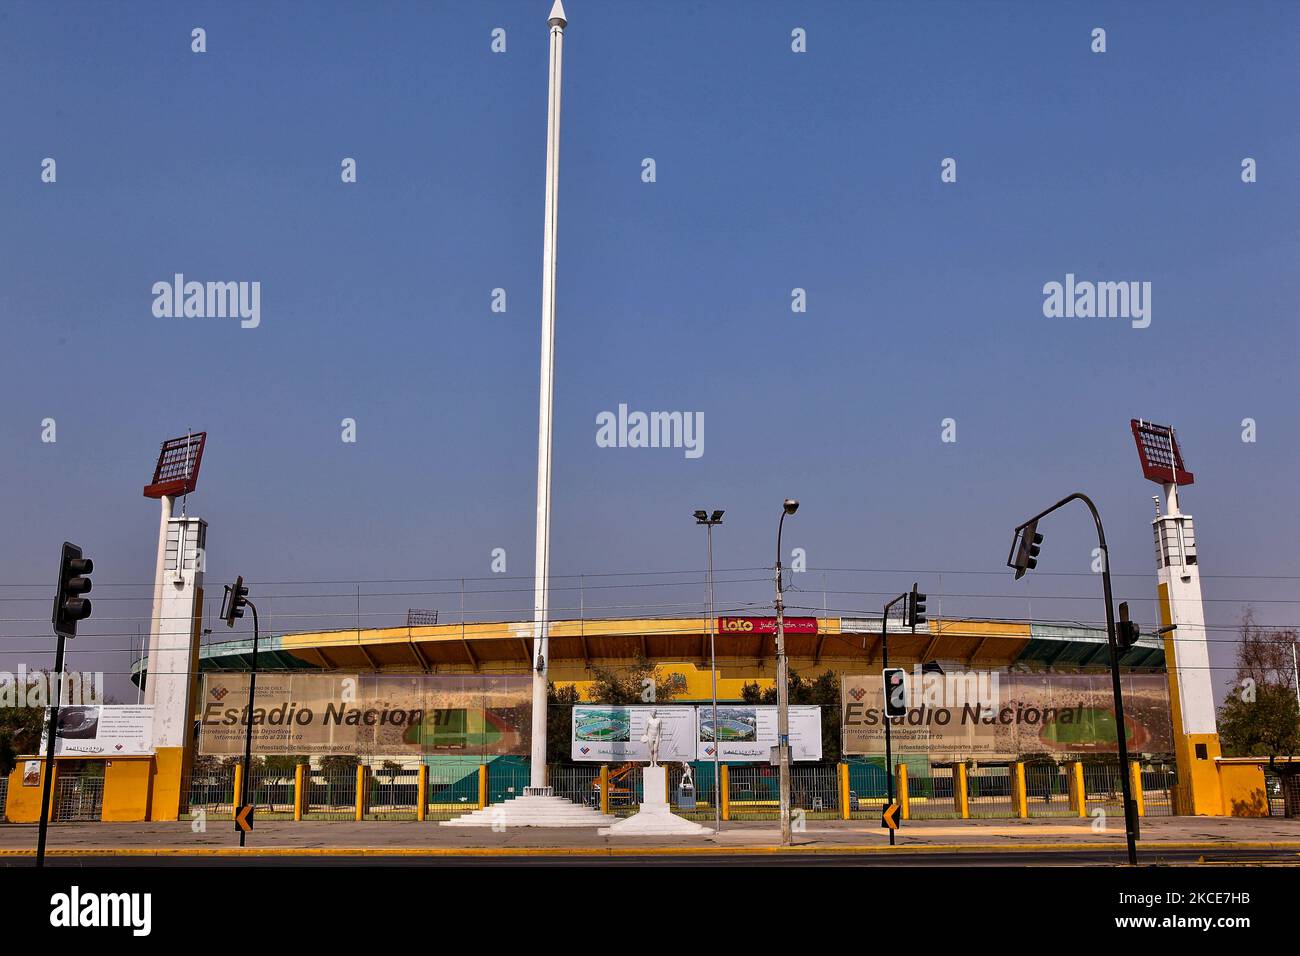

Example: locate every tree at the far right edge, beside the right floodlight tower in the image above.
[1218,611,1300,817]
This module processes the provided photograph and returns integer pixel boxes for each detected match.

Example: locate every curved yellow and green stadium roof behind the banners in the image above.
[133,618,1165,683]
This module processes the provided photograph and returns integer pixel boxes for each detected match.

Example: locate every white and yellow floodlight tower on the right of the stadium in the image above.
[1131,419,1223,816]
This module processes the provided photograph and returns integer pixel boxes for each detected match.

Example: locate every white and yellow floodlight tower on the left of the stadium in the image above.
[144,432,208,819]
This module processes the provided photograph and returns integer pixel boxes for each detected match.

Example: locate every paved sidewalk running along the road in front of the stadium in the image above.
[0,817,1300,857]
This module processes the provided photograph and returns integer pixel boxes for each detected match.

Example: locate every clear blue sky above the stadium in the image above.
[0,0,1300,697]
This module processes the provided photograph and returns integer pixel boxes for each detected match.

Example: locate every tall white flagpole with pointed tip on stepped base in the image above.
[529,0,568,793]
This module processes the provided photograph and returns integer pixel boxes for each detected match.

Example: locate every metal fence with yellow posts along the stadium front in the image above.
[167,761,1185,822]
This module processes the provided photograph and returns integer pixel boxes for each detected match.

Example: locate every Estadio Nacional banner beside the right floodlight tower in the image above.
[840,669,1174,761]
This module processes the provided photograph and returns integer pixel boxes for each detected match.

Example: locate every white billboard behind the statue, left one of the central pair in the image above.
[571,704,696,763]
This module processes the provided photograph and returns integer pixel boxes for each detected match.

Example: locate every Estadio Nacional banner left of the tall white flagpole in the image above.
[199,672,533,756]
